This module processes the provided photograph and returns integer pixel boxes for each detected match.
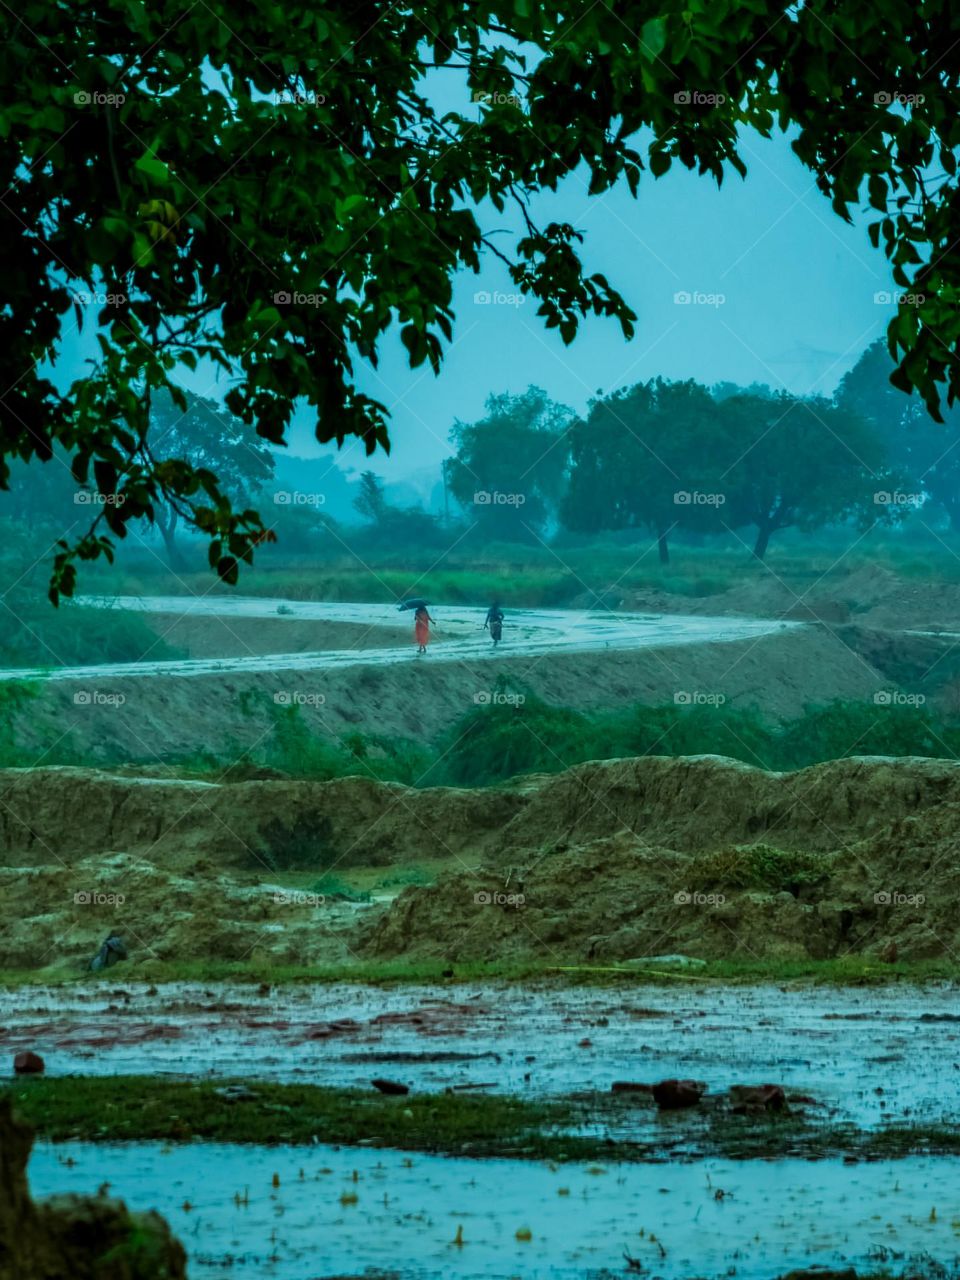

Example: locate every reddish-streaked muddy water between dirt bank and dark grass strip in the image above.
[7,980,960,1126]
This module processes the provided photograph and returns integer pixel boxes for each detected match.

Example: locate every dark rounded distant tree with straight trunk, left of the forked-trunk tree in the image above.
[562,379,722,564]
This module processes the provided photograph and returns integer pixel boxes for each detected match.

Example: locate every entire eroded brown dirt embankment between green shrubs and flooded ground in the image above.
[0,756,960,968]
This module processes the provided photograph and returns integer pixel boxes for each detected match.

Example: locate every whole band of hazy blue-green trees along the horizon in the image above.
[0,342,960,568]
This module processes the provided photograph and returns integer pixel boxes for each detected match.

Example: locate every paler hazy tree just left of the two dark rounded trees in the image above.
[445,387,572,543]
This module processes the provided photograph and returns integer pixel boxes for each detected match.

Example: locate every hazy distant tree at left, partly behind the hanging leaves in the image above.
[150,389,274,570]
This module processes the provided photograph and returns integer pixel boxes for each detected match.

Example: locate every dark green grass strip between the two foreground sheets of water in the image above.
[8,1075,960,1162]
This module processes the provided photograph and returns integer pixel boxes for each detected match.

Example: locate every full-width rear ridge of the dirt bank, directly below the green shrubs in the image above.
[7,756,960,872]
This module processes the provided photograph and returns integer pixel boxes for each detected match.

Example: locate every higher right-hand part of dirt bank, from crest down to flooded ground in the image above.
[361,758,960,961]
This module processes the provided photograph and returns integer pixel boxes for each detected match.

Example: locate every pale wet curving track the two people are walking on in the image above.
[0,595,801,680]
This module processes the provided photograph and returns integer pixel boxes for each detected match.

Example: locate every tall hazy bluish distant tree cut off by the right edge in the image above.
[837,340,960,534]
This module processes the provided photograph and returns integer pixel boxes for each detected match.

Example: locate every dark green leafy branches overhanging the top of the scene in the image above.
[0,0,960,600]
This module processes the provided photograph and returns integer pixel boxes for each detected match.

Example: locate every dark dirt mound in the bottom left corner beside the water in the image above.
[0,1098,187,1280]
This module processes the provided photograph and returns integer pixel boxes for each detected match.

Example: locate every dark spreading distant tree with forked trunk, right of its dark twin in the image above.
[718,384,901,559]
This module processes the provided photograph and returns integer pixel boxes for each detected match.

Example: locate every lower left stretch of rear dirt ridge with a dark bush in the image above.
[0,768,524,870]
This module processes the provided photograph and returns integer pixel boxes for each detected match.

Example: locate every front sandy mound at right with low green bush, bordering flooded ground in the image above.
[360,803,960,964]
